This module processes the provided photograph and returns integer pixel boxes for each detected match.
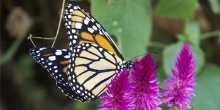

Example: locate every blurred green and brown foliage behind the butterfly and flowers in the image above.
[0,0,220,110]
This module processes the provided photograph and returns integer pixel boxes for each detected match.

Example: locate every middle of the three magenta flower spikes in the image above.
[130,54,161,110]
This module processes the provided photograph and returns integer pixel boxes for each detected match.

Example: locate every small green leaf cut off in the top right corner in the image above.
[209,0,220,14]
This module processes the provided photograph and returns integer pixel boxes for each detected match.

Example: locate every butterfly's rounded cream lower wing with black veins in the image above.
[65,43,125,101]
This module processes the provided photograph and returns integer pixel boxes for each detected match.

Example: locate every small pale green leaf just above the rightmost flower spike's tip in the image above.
[182,22,201,46]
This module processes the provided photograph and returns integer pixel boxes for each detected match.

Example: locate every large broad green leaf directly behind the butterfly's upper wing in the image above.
[91,0,151,59]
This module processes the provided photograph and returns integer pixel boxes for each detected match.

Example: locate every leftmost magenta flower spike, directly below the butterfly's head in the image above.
[100,69,130,110]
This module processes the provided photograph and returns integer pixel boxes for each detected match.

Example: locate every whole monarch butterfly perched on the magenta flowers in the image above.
[30,1,132,102]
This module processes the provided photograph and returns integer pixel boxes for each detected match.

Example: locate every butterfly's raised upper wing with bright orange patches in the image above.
[64,1,123,59]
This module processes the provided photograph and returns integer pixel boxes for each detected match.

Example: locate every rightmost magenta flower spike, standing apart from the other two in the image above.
[163,43,195,110]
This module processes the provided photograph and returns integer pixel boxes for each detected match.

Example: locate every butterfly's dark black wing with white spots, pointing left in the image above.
[30,48,78,100]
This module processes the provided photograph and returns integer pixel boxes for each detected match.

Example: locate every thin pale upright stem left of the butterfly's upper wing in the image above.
[51,0,66,48]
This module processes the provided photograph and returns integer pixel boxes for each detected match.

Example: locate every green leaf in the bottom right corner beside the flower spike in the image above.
[193,65,220,110]
